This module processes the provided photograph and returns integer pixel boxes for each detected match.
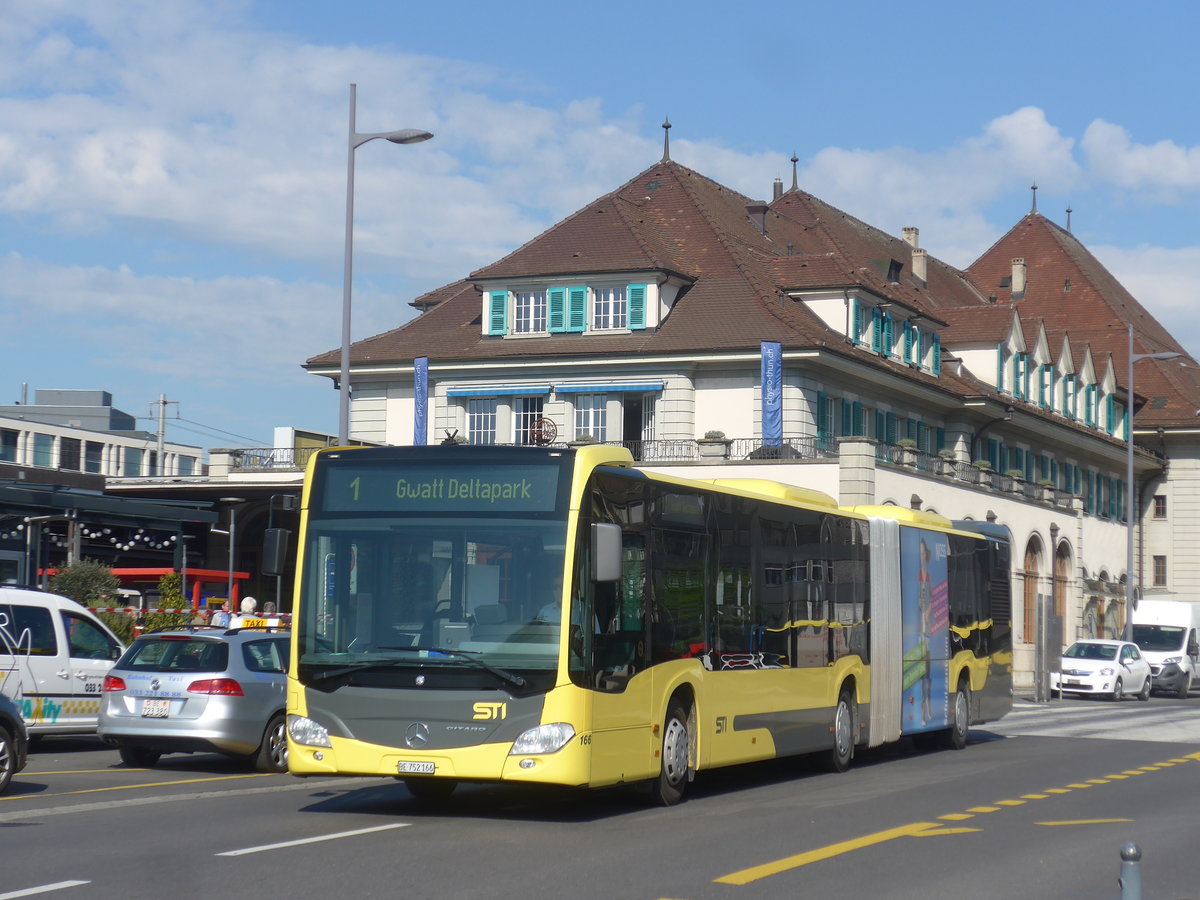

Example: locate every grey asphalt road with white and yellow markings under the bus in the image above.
[0,697,1200,900]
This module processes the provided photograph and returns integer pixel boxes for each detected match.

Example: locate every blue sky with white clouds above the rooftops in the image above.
[0,0,1200,449]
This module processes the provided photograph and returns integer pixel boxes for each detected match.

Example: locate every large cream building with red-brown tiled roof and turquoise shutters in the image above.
[306,146,1200,685]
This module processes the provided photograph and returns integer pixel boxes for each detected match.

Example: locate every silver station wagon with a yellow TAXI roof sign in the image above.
[98,626,289,772]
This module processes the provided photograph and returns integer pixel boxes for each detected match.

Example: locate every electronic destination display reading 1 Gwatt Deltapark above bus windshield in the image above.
[322,464,559,512]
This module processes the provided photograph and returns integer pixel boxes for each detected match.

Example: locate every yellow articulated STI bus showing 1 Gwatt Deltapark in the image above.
[288,445,1012,804]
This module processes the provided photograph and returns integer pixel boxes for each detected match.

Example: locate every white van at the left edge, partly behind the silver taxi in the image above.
[0,587,125,737]
